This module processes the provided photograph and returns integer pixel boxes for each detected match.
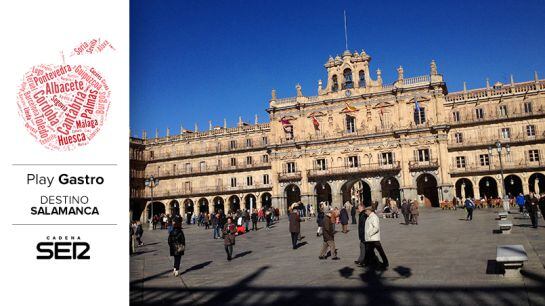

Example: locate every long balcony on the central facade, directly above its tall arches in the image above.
[308,161,401,179]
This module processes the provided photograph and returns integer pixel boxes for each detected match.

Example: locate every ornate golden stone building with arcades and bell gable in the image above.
[130,51,545,220]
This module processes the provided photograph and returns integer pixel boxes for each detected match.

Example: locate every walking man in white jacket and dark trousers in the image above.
[364,207,390,269]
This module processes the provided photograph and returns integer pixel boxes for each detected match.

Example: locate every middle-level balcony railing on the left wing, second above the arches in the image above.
[147,162,271,178]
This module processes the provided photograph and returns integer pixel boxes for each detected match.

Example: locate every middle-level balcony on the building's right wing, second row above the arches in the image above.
[448,132,545,151]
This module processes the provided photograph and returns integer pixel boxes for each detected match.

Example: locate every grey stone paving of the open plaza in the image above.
[130,209,545,305]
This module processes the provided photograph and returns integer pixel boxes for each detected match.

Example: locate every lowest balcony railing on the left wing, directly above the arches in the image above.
[144,184,272,199]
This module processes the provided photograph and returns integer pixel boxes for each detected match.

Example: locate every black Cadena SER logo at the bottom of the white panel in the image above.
[36,236,91,260]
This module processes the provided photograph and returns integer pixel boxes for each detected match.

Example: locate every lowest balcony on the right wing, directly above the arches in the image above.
[450,159,545,176]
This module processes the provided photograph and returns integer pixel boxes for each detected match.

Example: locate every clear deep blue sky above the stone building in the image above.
[130,0,545,135]
